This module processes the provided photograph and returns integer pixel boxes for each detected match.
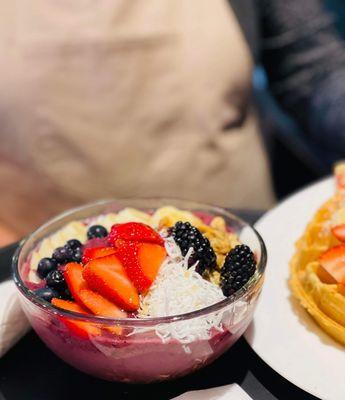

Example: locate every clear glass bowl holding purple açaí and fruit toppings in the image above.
[13,199,266,383]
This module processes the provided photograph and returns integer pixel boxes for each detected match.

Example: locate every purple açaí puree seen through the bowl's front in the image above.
[22,296,251,382]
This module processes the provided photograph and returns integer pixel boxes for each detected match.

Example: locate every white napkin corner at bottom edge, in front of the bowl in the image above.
[172,383,253,400]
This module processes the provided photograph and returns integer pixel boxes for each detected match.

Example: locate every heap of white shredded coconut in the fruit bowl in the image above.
[133,237,225,344]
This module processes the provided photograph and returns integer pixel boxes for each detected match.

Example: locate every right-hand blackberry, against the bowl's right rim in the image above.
[220,244,256,296]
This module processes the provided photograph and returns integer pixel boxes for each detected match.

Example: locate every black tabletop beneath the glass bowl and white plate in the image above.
[0,211,315,400]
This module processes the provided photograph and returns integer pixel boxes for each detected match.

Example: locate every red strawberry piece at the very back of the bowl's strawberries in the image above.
[108,222,164,246]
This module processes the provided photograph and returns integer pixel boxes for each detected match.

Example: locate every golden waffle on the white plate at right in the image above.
[289,164,345,346]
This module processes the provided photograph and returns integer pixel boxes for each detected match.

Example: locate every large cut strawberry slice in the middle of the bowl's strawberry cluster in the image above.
[83,255,139,311]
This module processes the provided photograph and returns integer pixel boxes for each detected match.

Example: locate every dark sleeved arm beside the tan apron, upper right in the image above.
[257,0,345,158]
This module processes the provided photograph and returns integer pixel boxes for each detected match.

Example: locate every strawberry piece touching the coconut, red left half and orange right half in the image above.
[116,241,166,293]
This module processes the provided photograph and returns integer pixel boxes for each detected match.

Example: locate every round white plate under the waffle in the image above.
[245,179,345,400]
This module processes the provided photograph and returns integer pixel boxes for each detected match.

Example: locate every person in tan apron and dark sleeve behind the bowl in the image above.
[0,0,345,245]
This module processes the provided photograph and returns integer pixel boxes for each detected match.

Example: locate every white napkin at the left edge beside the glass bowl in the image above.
[0,281,30,357]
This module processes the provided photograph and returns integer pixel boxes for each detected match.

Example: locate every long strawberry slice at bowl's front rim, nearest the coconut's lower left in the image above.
[80,289,127,335]
